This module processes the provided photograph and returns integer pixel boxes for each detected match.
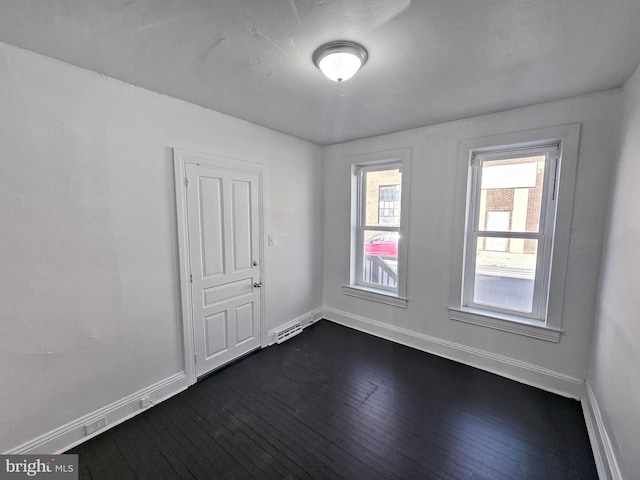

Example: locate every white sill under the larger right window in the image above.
[449,307,562,343]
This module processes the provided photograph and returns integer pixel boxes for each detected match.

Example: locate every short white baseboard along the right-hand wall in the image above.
[582,381,622,480]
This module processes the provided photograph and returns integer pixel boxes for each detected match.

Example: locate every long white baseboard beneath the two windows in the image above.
[323,307,585,399]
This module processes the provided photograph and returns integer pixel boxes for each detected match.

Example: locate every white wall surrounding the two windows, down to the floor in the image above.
[323,91,620,396]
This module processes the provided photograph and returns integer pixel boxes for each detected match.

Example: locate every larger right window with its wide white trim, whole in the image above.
[449,125,580,342]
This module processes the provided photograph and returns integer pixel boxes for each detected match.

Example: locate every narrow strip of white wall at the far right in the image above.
[589,62,640,479]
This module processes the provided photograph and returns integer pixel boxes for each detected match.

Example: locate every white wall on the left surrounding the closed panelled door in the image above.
[0,44,322,451]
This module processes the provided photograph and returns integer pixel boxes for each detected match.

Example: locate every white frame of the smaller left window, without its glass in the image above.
[342,148,411,308]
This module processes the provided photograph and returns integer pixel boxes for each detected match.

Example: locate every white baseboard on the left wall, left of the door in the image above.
[5,372,188,455]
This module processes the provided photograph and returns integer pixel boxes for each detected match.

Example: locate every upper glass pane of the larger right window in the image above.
[478,155,546,232]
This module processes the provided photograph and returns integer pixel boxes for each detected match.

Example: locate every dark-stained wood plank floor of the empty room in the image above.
[68,321,598,480]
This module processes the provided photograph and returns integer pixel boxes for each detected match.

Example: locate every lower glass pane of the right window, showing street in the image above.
[473,237,538,313]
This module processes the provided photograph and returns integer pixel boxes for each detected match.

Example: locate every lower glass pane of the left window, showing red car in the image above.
[362,230,400,288]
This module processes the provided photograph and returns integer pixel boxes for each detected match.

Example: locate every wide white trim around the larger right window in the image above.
[449,124,580,342]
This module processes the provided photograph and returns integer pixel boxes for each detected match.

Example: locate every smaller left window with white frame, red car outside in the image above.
[343,150,409,307]
